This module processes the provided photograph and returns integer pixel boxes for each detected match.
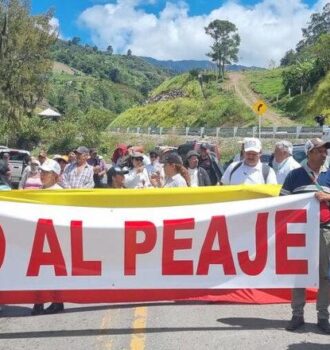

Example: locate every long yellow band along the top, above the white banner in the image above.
[0,185,280,208]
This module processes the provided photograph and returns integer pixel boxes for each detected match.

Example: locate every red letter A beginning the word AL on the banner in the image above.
[26,219,67,276]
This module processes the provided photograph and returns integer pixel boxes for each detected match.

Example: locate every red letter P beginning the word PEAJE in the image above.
[124,221,157,275]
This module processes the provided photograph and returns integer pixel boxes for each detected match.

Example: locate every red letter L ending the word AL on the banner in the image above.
[71,221,102,276]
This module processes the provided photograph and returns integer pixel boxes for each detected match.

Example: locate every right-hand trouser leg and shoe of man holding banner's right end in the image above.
[316,227,330,334]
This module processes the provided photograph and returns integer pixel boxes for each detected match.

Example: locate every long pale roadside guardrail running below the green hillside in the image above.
[108,126,329,139]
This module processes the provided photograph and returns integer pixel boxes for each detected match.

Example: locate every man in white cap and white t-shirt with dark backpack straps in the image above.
[221,137,277,185]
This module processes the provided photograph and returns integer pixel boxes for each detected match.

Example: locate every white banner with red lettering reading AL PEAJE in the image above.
[0,194,319,292]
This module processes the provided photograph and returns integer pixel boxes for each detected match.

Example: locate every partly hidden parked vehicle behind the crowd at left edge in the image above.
[0,148,30,187]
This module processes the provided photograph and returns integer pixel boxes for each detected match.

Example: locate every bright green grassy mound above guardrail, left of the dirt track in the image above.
[110,73,256,127]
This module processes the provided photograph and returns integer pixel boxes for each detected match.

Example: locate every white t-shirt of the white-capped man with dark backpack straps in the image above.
[221,161,277,185]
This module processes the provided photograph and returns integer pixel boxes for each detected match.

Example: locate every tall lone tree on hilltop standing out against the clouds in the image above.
[205,19,241,79]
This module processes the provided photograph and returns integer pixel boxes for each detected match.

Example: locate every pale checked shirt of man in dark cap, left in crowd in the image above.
[60,163,94,188]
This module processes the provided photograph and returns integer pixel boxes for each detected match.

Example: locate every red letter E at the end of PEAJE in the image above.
[275,209,308,275]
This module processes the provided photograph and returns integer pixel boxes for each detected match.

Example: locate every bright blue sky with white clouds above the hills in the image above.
[32,0,329,67]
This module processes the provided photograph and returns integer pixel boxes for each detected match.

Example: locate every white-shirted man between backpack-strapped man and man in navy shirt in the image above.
[272,140,301,184]
